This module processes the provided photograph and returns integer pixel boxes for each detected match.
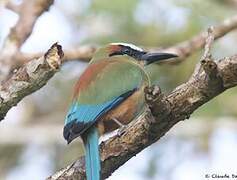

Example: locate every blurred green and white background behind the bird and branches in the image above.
[0,0,237,180]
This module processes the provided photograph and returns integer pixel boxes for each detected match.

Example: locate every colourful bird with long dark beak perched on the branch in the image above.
[63,43,176,180]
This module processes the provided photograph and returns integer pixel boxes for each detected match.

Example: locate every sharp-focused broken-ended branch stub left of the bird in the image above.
[0,44,63,119]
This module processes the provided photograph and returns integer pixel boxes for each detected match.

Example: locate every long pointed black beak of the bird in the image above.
[141,52,178,65]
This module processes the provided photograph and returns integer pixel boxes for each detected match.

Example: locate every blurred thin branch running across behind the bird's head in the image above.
[15,15,237,65]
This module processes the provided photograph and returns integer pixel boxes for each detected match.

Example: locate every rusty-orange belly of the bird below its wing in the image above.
[98,90,144,134]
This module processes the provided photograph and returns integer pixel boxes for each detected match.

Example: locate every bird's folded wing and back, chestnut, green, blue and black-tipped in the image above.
[64,58,146,140]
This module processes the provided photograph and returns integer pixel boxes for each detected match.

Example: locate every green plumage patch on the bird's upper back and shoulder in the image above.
[77,56,149,104]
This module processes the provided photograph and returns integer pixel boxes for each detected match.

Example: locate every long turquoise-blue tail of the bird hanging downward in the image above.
[83,127,101,180]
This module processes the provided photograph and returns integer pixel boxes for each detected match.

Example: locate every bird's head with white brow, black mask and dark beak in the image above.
[92,43,178,65]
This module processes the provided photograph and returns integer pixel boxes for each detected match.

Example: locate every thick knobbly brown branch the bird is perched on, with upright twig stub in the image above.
[48,29,237,180]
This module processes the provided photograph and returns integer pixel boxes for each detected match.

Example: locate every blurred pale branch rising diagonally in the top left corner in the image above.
[0,0,54,81]
